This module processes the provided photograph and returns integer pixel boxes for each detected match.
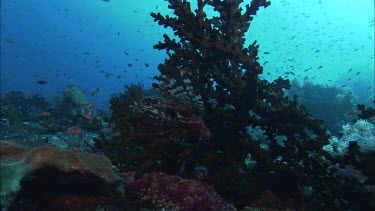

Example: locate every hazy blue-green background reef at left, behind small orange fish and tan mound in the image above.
[0,88,109,151]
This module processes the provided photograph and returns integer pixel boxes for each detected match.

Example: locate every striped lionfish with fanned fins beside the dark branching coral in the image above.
[137,70,211,143]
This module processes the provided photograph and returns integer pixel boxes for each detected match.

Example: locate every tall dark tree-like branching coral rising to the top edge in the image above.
[143,0,375,209]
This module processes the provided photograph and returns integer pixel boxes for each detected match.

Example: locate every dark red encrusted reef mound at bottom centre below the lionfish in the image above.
[124,172,237,210]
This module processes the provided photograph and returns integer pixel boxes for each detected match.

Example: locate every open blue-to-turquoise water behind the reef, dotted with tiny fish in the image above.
[1,0,374,108]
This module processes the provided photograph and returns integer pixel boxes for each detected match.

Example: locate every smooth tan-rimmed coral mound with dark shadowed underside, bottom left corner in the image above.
[0,142,124,210]
